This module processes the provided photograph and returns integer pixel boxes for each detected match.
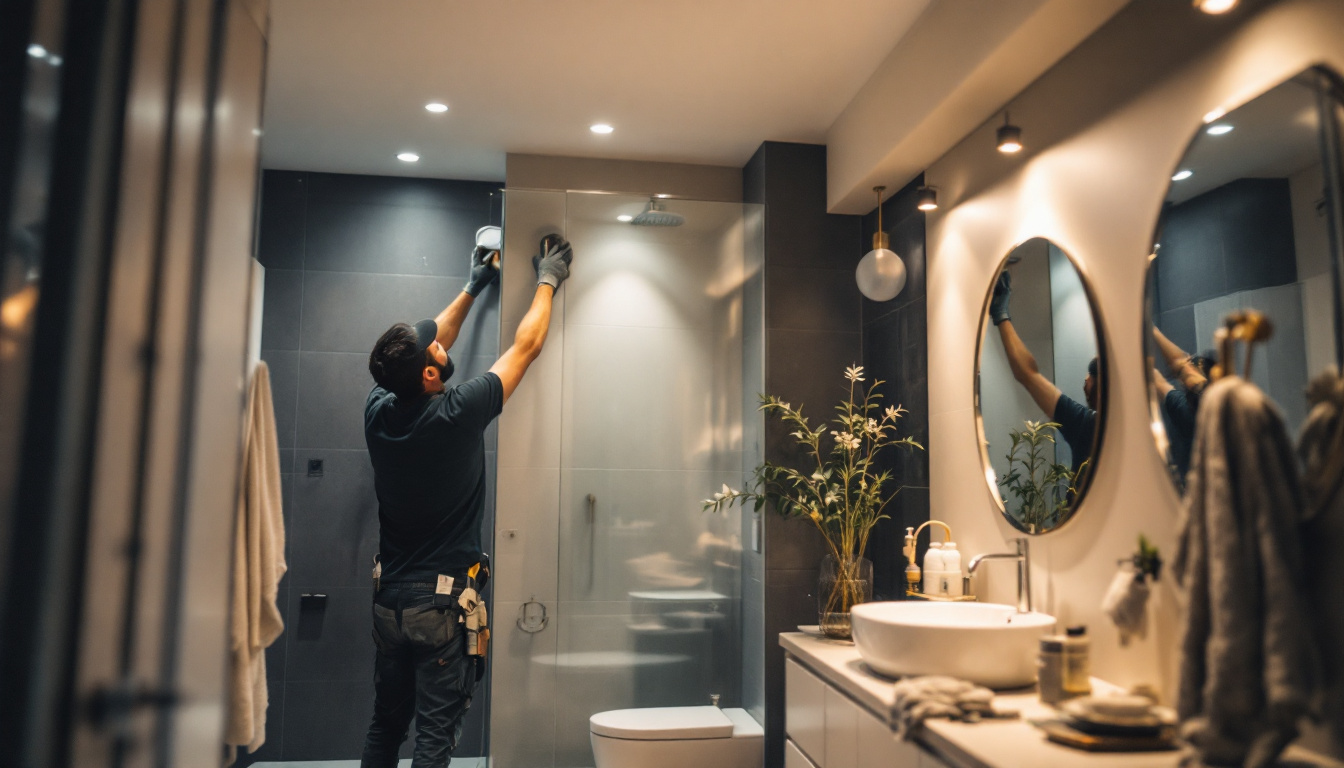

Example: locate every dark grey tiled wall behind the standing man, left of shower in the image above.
[241,171,503,765]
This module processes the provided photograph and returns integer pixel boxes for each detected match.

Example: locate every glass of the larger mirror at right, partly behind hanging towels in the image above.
[1146,70,1344,490]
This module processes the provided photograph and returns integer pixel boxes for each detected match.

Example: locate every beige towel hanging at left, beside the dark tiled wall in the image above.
[224,363,286,751]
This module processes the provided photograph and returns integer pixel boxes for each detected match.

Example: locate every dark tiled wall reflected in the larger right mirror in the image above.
[1153,179,1297,352]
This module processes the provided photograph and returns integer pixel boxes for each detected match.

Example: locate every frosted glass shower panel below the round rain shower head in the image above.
[554,192,743,767]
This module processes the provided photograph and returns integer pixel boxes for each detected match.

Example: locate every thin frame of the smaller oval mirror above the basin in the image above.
[973,235,1110,535]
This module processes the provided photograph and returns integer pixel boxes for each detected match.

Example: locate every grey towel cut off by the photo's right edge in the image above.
[1297,367,1344,751]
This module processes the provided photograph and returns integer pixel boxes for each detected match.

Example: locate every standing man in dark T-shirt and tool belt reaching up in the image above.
[360,235,573,768]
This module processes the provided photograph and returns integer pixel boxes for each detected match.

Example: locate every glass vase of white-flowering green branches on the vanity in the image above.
[704,366,923,638]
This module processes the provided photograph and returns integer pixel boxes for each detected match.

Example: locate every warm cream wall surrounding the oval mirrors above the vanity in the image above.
[926,0,1344,710]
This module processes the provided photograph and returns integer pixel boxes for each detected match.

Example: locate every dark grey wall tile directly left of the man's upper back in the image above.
[294,352,374,454]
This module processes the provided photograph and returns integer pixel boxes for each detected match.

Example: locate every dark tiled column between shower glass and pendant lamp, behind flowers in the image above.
[742,141,863,768]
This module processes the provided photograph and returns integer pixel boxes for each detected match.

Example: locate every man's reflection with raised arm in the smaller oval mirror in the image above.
[989,269,1097,475]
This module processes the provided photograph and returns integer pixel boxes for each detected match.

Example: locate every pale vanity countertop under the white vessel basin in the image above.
[780,632,1344,768]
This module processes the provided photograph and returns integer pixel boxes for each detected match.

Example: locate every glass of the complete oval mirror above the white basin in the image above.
[976,238,1106,534]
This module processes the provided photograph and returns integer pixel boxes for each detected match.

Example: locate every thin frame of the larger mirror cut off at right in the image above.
[1139,63,1344,496]
